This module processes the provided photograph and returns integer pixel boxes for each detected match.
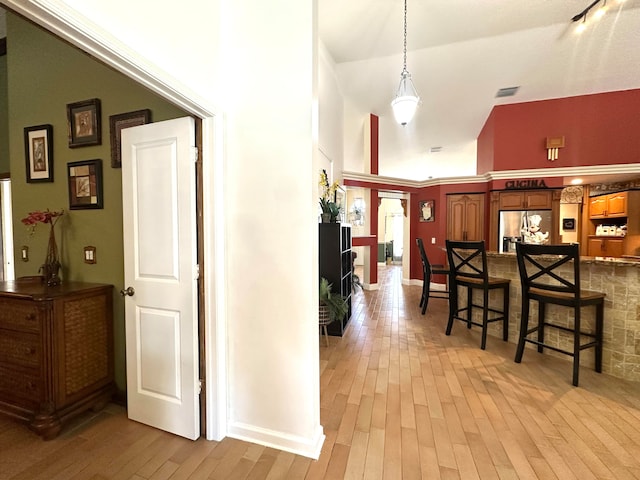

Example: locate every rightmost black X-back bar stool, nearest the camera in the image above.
[515,243,605,387]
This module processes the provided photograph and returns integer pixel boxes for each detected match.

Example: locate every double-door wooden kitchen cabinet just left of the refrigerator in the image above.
[447,193,484,241]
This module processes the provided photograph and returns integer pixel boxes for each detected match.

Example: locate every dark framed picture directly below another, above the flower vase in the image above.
[67,160,103,210]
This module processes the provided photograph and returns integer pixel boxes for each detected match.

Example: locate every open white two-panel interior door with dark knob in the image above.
[122,117,200,439]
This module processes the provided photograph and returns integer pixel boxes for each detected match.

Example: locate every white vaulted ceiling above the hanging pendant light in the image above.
[318,0,640,180]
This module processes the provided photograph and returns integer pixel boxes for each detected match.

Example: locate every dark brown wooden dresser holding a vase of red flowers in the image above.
[0,280,114,440]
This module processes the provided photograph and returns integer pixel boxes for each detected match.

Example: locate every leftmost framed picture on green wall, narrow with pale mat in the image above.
[24,125,53,183]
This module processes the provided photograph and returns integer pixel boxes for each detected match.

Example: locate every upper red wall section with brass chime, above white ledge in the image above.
[478,90,640,174]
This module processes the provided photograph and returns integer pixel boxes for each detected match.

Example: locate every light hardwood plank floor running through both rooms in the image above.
[0,267,640,480]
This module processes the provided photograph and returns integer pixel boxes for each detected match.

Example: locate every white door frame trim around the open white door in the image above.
[3,0,227,440]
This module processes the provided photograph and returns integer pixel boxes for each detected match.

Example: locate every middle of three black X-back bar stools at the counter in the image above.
[446,240,511,350]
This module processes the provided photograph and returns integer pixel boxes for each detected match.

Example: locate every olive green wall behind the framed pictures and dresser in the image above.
[6,13,186,391]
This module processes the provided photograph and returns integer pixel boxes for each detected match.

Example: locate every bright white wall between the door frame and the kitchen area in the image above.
[15,0,324,457]
